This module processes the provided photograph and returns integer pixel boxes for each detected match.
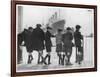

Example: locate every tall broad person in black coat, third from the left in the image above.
[32,24,45,64]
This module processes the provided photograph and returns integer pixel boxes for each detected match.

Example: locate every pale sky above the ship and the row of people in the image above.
[16,5,94,35]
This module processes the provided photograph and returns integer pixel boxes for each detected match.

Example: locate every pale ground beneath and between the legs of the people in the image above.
[16,38,94,72]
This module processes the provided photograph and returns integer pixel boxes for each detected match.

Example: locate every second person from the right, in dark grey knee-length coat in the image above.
[62,27,73,64]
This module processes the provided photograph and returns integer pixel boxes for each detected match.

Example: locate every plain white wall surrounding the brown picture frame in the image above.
[0,0,100,77]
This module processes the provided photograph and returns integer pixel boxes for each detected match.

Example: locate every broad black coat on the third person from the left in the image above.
[32,27,45,51]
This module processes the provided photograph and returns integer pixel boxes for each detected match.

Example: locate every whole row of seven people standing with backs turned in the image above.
[17,24,83,65]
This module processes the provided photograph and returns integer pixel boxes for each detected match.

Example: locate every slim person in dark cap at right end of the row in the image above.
[74,25,83,64]
